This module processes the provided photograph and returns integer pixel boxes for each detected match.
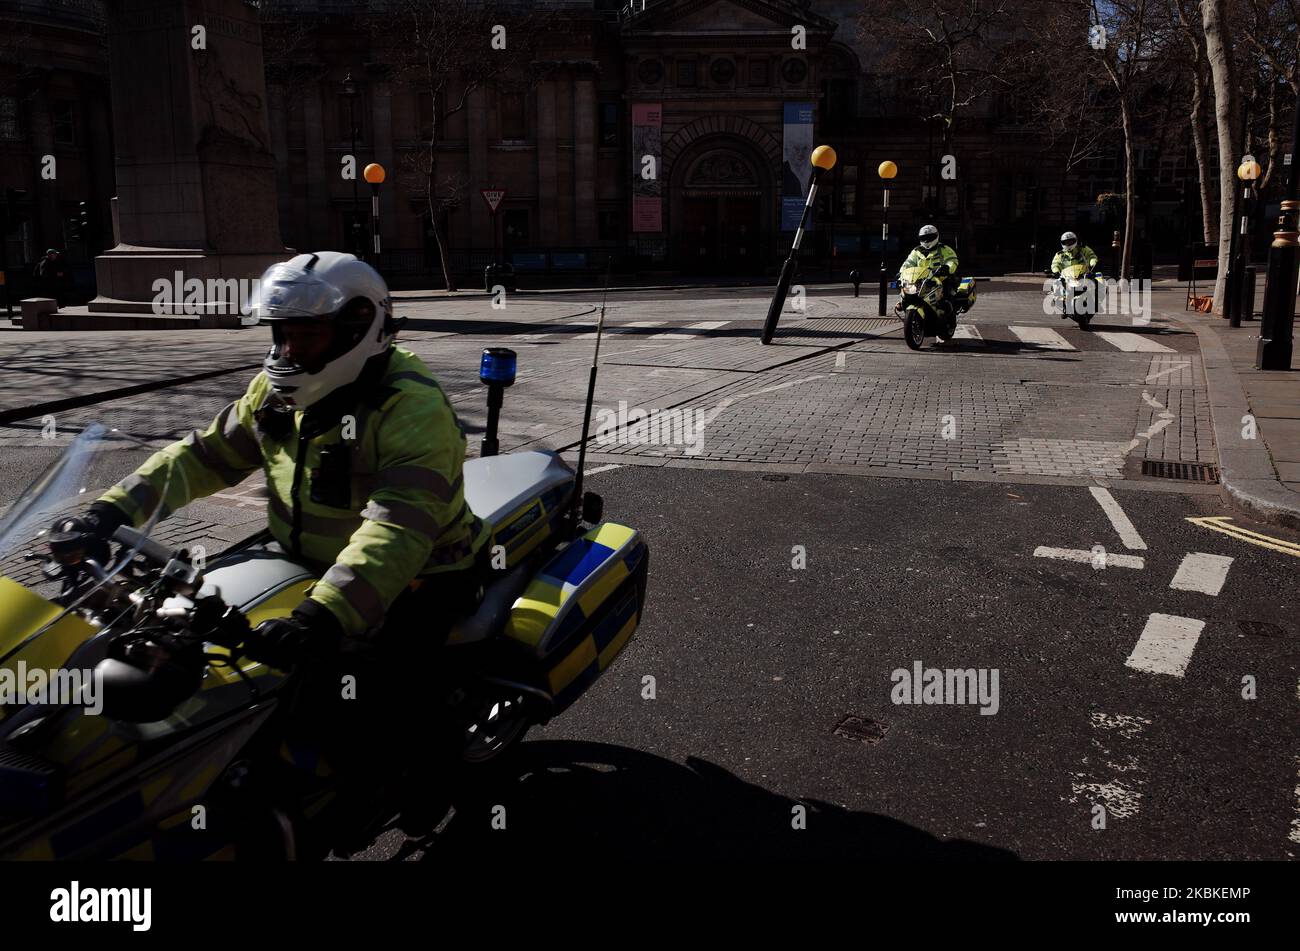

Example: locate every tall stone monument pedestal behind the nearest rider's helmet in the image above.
[90,0,289,325]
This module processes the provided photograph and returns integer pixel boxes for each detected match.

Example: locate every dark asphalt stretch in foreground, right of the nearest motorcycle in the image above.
[363,468,1300,860]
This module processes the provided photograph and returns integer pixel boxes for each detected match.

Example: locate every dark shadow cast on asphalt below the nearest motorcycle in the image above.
[424,741,1017,861]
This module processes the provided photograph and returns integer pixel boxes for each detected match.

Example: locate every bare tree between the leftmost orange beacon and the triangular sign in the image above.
[369,0,545,291]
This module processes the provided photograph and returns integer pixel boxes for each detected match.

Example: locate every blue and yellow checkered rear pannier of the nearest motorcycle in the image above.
[506,522,647,711]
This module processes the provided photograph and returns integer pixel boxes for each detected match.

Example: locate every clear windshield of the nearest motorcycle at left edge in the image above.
[0,422,170,643]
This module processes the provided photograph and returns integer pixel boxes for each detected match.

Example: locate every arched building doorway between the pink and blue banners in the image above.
[672,138,771,274]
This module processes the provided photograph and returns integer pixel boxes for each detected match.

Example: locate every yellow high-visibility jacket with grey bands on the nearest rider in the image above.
[103,347,490,635]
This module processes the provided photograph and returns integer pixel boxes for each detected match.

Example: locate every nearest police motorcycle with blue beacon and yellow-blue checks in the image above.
[0,348,649,860]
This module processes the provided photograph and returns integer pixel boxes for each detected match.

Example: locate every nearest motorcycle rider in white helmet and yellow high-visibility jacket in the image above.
[53,251,490,836]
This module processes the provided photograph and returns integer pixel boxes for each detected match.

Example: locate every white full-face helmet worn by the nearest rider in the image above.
[250,251,397,409]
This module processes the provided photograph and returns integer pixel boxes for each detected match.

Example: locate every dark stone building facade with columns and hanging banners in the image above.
[0,0,1191,286]
